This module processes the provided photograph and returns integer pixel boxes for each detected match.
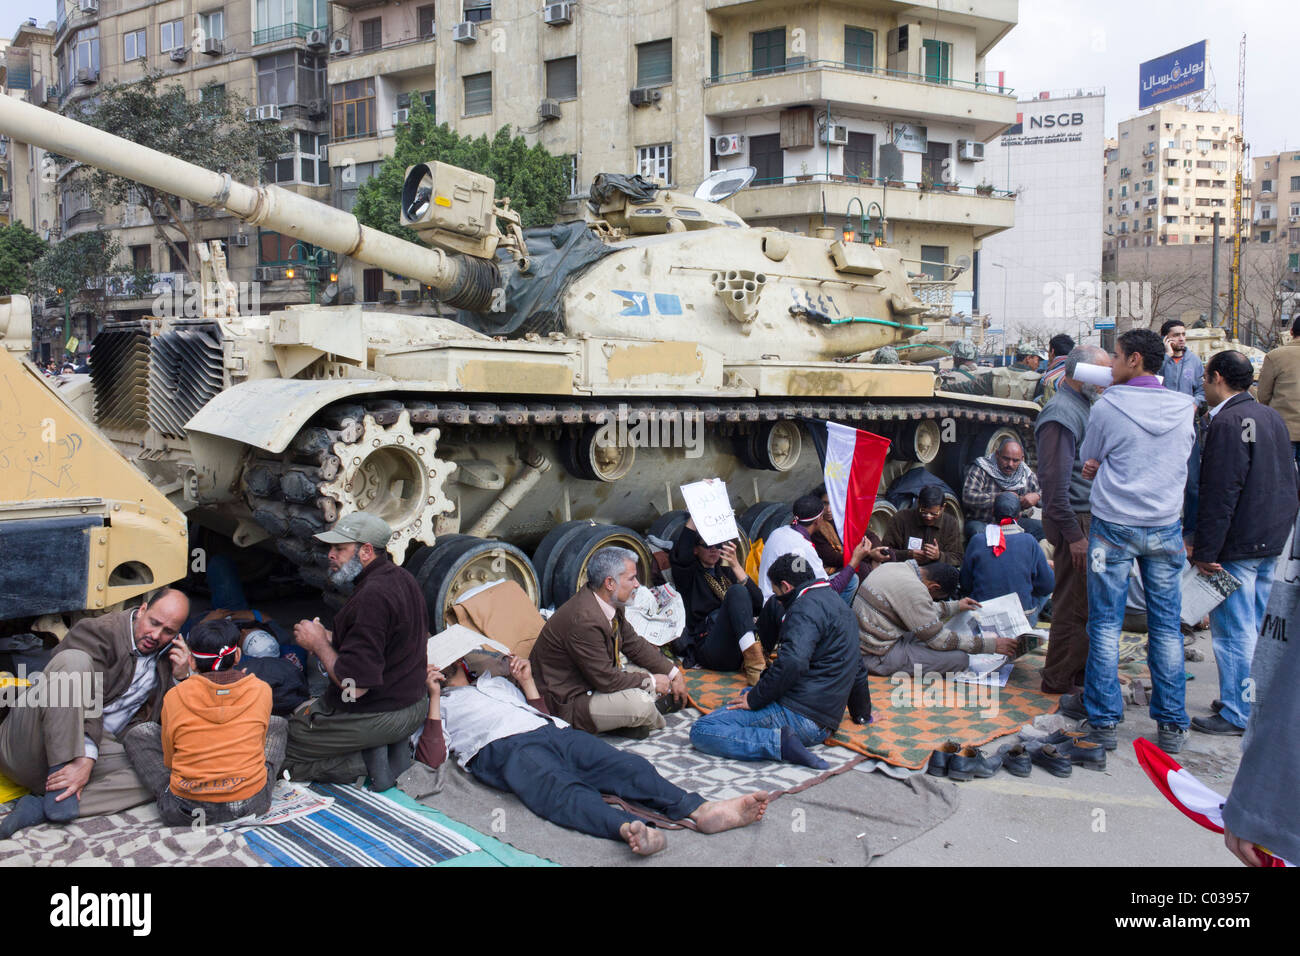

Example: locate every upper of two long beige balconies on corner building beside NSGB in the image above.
[705,60,1017,142]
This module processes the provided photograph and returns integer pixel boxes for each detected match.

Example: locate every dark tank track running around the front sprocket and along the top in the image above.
[243,398,1035,590]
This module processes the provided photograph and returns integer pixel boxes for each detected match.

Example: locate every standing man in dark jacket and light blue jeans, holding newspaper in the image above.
[1192,350,1296,735]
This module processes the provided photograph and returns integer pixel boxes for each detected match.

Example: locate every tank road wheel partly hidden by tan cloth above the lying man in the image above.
[407,535,541,633]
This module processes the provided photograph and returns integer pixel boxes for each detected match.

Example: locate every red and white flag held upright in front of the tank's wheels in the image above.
[803,419,889,562]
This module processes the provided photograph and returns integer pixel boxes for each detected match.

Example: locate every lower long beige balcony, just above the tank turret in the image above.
[724,174,1015,239]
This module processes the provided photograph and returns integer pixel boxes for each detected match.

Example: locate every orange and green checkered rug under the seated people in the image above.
[686,649,1057,770]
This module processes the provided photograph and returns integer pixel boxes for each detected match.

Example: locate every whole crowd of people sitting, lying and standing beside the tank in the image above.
[0,323,1300,858]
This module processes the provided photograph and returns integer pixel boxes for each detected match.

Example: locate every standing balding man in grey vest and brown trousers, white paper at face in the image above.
[1034,345,1112,693]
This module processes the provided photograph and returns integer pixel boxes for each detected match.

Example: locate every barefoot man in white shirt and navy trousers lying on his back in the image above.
[416,641,768,856]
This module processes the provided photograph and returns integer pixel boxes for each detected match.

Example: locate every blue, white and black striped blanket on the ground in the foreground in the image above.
[241,783,478,866]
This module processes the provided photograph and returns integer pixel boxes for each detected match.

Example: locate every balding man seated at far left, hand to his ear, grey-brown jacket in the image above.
[0,588,190,839]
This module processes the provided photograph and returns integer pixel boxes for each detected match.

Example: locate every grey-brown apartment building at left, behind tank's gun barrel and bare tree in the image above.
[20,0,332,342]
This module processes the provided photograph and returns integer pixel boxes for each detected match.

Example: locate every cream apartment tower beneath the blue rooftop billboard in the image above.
[1102,107,1249,252]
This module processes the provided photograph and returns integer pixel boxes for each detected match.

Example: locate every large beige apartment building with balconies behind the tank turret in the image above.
[328,0,1018,298]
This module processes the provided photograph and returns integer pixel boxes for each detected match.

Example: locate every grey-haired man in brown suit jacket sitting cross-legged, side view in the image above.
[529,548,686,737]
